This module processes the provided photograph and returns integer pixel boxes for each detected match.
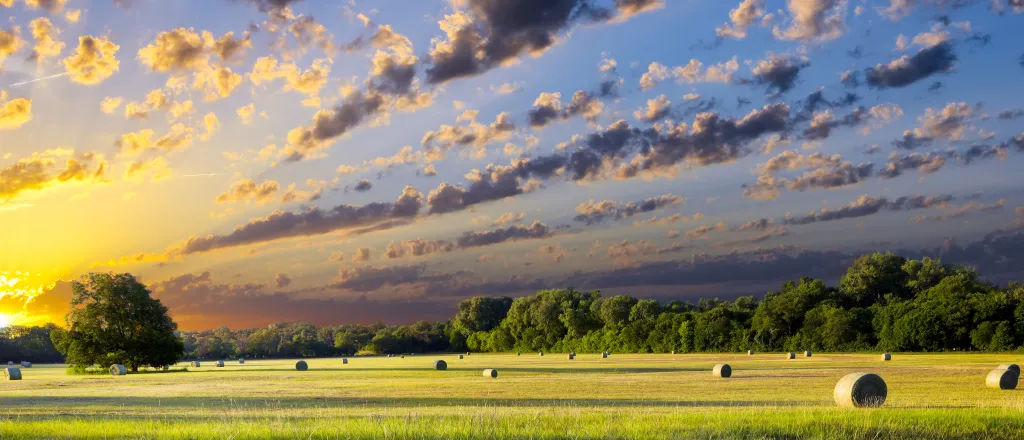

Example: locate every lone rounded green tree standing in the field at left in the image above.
[51,273,184,371]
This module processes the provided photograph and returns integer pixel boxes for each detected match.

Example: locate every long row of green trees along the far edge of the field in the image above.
[0,254,1024,366]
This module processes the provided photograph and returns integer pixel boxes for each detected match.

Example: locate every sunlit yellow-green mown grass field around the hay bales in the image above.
[0,353,1024,440]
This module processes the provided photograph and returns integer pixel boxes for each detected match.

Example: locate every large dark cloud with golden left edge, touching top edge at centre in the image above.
[427,0,664,84]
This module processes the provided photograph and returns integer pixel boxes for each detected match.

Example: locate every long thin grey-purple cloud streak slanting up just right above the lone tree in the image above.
[171,186,423,255]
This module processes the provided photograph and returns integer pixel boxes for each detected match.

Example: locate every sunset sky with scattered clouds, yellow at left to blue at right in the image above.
[0,0,1024,329]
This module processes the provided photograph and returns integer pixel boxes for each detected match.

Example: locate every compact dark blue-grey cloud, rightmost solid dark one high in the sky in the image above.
[864,42,956,89]
